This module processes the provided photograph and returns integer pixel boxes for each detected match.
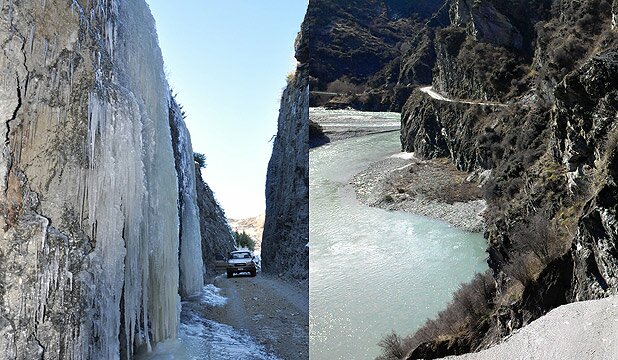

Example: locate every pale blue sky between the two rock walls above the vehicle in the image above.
[147,0,308,218]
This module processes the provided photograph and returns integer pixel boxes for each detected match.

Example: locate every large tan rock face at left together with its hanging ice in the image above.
[0,0,209,359]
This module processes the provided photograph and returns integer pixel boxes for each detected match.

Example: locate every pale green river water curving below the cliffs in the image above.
[309,129,487,360]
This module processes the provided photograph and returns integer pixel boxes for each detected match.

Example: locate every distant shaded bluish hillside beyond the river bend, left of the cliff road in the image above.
[303,0,448,112]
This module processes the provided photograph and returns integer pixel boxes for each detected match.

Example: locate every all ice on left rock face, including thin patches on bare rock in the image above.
[11,0,209,360]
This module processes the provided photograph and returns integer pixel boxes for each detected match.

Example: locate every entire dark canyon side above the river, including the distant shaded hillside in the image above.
[306,0,618,359]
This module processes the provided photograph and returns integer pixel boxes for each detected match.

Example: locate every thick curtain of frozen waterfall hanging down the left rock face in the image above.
[80,0,203,359]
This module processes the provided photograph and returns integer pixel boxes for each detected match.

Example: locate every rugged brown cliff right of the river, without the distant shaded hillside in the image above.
[394,0,618,358]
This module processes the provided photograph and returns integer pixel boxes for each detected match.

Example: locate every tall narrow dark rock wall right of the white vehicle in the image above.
[262,32,309,280]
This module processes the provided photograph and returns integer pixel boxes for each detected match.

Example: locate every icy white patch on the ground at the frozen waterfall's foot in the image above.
[136,285,279,360]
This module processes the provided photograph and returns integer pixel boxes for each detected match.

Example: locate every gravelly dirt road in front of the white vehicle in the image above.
[208,273,309,360]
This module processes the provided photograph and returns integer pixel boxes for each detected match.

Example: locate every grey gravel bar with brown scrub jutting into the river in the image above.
[352,153,486,232]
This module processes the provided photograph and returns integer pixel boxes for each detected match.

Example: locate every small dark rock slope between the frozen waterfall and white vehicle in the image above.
[195,164,236,275]
